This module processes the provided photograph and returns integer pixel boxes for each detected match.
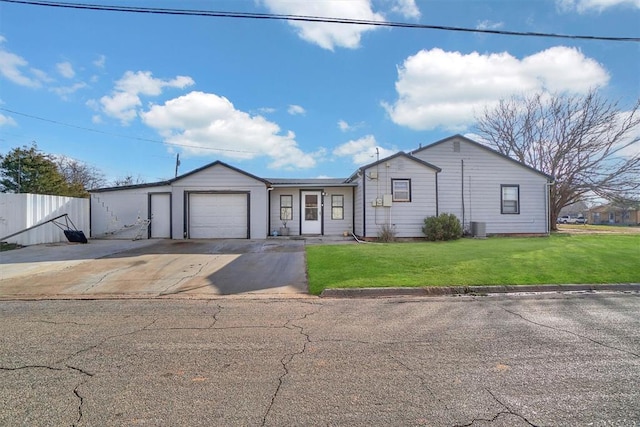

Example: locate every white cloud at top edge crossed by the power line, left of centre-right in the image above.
[262,0,384,50]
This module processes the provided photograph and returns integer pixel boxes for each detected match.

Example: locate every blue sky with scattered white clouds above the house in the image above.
[0,0,640,182]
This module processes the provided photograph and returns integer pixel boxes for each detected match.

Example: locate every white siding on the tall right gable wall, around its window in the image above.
[414,138,548,234]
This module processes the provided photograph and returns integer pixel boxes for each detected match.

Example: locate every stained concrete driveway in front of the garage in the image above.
[0,239,307,299]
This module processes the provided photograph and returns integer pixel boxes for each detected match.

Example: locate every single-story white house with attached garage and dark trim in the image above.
[90,135,552,239]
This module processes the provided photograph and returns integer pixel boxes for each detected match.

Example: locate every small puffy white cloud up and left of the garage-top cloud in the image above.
[100,71,194,124]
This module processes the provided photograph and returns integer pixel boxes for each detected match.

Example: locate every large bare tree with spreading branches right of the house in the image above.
[476,90,640,227]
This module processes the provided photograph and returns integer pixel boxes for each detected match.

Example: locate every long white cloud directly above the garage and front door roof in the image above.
[141,92,316,169]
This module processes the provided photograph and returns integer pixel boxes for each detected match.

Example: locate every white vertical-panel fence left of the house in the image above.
[0,193,90,246]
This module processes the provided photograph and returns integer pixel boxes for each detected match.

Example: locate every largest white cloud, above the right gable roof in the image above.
[382,46,609,132]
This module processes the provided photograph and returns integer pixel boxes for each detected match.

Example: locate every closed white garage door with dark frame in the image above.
[189,193,249,239]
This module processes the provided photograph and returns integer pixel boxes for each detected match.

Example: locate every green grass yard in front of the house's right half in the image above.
[306,234,640,295]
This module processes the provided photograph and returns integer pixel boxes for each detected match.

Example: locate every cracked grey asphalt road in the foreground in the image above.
[0,293,640,426]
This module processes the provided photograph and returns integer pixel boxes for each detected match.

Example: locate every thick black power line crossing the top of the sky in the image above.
[0,0,640,42]
